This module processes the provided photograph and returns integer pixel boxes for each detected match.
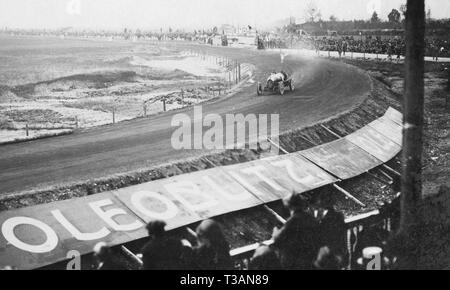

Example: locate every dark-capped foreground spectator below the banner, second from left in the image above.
[142,221,187,270]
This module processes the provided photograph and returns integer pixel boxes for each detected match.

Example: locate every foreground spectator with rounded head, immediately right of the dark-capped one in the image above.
[193,220,233,270]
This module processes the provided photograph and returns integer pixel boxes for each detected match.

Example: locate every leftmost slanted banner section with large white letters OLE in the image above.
[0,193,147,269]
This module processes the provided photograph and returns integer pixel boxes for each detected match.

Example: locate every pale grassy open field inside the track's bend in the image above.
[0,36,246,142]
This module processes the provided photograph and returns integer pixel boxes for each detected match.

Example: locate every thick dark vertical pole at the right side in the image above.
[398,0,425,269]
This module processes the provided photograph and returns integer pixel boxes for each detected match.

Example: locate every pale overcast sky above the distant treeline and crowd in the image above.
[0,0,450,29]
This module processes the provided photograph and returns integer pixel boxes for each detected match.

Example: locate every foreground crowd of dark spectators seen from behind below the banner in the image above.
[89,189,400,270]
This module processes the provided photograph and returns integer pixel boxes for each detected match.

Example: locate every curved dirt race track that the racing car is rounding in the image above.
[0,44,371,194]
